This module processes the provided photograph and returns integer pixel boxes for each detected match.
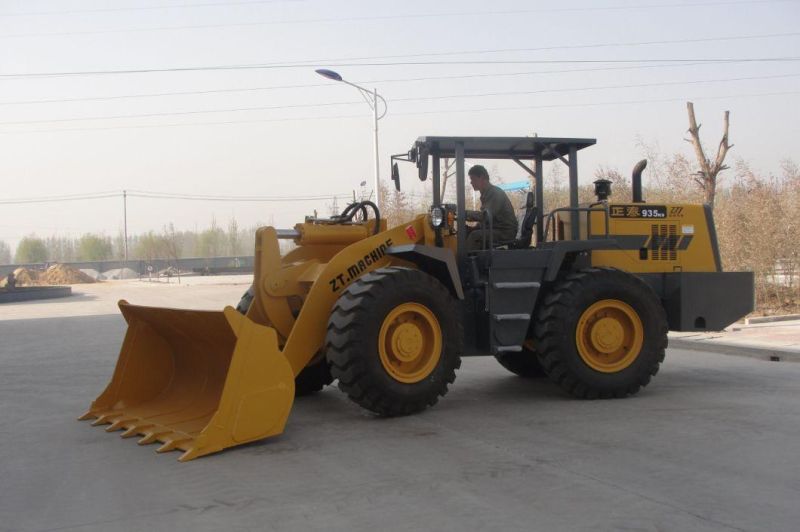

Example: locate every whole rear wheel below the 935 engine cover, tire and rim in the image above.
[534,268,668,399]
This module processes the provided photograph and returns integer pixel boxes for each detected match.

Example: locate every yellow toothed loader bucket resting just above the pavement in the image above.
[79,301,294,462]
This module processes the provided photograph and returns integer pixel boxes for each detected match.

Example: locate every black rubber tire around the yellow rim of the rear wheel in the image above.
[534,268,668,399]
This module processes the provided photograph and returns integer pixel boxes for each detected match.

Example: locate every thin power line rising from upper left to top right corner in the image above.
[0,0,796,38]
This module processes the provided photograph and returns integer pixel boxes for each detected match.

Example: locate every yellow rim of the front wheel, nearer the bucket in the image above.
[378,303,442,384]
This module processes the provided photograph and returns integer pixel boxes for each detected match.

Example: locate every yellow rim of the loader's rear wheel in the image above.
[575,299,644,373]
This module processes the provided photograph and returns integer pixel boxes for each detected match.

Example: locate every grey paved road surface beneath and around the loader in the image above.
[0,315,800,531]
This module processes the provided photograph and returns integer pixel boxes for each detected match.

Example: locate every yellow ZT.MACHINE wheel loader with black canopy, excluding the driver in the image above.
[81,137,753,461]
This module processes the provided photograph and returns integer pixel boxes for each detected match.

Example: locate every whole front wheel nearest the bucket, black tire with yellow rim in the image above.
[325,268,463,416]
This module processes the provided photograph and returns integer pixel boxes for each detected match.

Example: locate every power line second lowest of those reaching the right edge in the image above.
[0,73,800,126]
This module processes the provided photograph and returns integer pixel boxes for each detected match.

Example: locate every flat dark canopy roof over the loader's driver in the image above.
[415,137,597,161]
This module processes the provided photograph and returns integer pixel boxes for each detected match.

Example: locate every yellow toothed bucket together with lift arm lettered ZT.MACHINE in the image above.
[80,216,431,461]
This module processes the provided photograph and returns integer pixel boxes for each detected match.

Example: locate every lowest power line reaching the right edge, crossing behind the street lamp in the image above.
[0,91,800,134]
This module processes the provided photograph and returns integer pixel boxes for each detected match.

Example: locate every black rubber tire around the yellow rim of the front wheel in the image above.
[325,267,463,416]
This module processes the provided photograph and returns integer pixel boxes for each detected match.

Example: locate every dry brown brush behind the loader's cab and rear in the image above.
[381,158,800,315]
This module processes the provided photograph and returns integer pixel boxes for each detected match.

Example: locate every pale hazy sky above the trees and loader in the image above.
[0,0,800,250]
